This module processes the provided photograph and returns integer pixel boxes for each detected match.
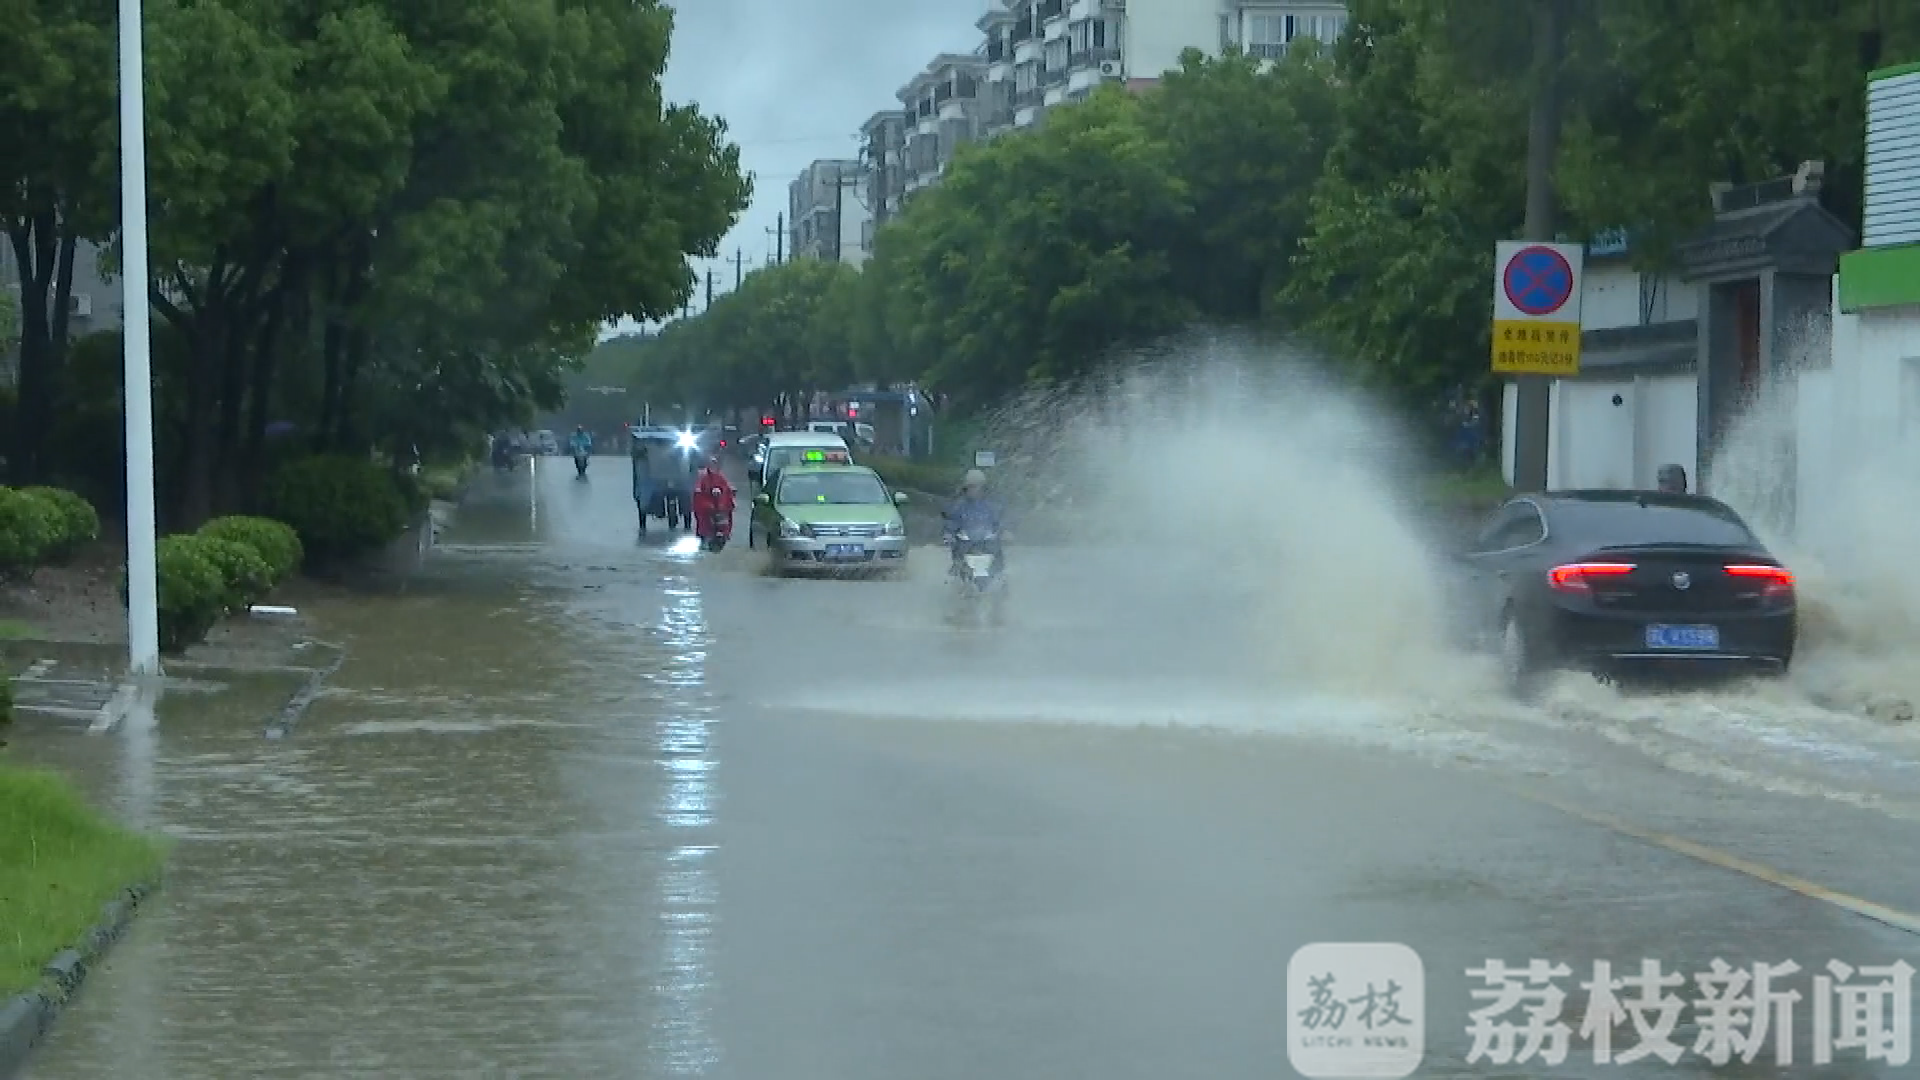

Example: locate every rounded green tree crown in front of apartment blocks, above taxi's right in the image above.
[887,86,1192,404]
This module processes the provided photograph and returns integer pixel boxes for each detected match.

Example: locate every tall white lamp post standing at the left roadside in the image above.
[119,0,159,675]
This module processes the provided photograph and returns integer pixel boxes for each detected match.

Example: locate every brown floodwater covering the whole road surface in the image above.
[19,457,1920,1080]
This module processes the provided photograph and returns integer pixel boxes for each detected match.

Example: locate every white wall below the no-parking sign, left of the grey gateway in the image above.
[1501,375,1699,490]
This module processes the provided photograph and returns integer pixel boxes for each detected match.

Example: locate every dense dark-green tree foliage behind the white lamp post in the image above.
[0,0,749,523]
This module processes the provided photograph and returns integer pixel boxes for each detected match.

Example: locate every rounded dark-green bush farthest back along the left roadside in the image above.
[265,455,407,561]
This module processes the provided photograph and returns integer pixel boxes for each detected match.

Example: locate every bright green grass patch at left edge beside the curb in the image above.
[0,765,165,997]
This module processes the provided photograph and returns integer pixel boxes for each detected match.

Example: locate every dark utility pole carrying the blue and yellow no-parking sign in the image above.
[1513,0,1567,492]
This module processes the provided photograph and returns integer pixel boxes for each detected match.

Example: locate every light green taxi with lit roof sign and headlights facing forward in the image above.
[747,463,906,573]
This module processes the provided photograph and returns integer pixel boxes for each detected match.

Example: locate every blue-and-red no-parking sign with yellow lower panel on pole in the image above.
[1494,240,1586,377]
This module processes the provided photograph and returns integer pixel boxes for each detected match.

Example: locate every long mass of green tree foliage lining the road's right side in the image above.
[572,0,1920,438]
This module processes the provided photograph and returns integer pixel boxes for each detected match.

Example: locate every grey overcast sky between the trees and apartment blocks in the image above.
[602,0,987,331]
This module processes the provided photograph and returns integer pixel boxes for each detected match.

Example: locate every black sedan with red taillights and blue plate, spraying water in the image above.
[1463,490,1795,698]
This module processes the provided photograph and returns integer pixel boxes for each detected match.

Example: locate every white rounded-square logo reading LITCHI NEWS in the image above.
[1286,942,1427,1080]
